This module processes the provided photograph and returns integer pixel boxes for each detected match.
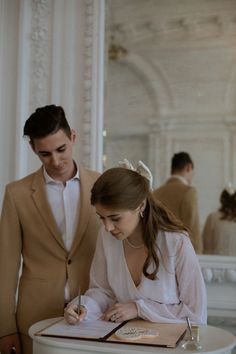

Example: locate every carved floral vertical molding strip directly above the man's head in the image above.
[30,0,51,111]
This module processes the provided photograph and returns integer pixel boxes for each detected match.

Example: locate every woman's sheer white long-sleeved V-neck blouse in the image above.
[80,226,207,324]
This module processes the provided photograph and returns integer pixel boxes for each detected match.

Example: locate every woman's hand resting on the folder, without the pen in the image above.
[101,302,138,322]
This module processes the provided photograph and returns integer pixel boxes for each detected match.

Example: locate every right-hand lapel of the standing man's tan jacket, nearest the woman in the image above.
[70,166,94,255]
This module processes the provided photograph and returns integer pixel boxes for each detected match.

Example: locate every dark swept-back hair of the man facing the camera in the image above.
[23,105,71,144]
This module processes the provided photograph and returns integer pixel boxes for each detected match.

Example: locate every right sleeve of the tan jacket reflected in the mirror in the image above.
[181,187,202,253]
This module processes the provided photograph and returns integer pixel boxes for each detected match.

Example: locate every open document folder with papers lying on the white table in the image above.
[35,318,187,348]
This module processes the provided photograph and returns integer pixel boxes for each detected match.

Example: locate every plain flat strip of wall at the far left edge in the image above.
[0,1,19,202]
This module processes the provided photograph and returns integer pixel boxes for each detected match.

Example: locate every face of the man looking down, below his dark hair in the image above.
[32,130,76,182]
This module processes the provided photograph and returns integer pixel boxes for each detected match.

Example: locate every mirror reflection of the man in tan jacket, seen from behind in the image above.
[153,152,202,254]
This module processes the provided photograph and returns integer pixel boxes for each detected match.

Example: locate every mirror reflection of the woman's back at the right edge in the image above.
[202,183,236,257]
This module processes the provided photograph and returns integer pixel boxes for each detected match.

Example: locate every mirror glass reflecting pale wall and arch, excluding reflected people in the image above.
[104,0,236,232]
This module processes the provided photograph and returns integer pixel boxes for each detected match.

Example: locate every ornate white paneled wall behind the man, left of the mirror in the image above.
[0,0,104,205]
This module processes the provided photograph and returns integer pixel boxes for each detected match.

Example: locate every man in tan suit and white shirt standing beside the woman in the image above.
[0,105,100,354]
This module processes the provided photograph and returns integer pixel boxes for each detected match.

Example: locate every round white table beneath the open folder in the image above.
[29,318,236,354]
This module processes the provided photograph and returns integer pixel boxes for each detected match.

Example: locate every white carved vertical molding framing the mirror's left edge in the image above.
[83,0,105,171]
